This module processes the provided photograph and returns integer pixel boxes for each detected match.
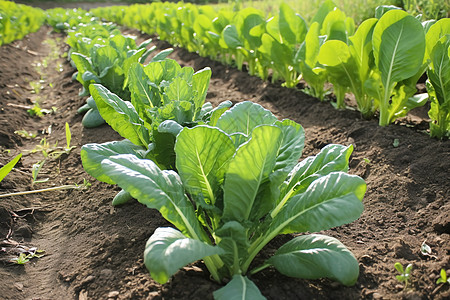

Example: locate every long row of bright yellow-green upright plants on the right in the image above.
[93,1,450,138]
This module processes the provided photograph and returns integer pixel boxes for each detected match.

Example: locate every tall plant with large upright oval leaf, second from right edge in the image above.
[365,9,427,126]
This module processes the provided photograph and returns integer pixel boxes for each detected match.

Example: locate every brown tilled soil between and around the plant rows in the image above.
[0,27,450,299]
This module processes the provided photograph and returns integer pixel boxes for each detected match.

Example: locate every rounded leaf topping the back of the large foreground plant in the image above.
[216,101,277,136]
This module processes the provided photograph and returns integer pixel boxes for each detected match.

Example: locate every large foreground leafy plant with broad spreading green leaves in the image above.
[82,102,366,299]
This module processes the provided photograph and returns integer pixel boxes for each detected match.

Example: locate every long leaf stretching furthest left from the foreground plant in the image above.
[101,154,208,241]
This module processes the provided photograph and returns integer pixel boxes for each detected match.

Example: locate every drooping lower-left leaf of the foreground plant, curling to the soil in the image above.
[144,227,223,284]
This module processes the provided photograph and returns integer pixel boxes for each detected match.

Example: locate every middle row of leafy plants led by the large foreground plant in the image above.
[42,2,366,299]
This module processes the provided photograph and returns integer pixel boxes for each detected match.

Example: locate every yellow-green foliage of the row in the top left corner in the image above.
[0,0,45,46]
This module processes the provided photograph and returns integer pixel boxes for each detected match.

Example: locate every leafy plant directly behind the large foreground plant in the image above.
[90,59,212,169]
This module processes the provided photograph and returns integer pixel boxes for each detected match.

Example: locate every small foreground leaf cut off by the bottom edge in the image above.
[213,274,266,300]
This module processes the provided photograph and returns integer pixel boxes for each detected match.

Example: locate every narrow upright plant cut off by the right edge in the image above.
[426,19,450,138]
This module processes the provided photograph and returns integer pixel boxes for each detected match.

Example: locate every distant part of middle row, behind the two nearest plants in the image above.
[47,8,173,128]
